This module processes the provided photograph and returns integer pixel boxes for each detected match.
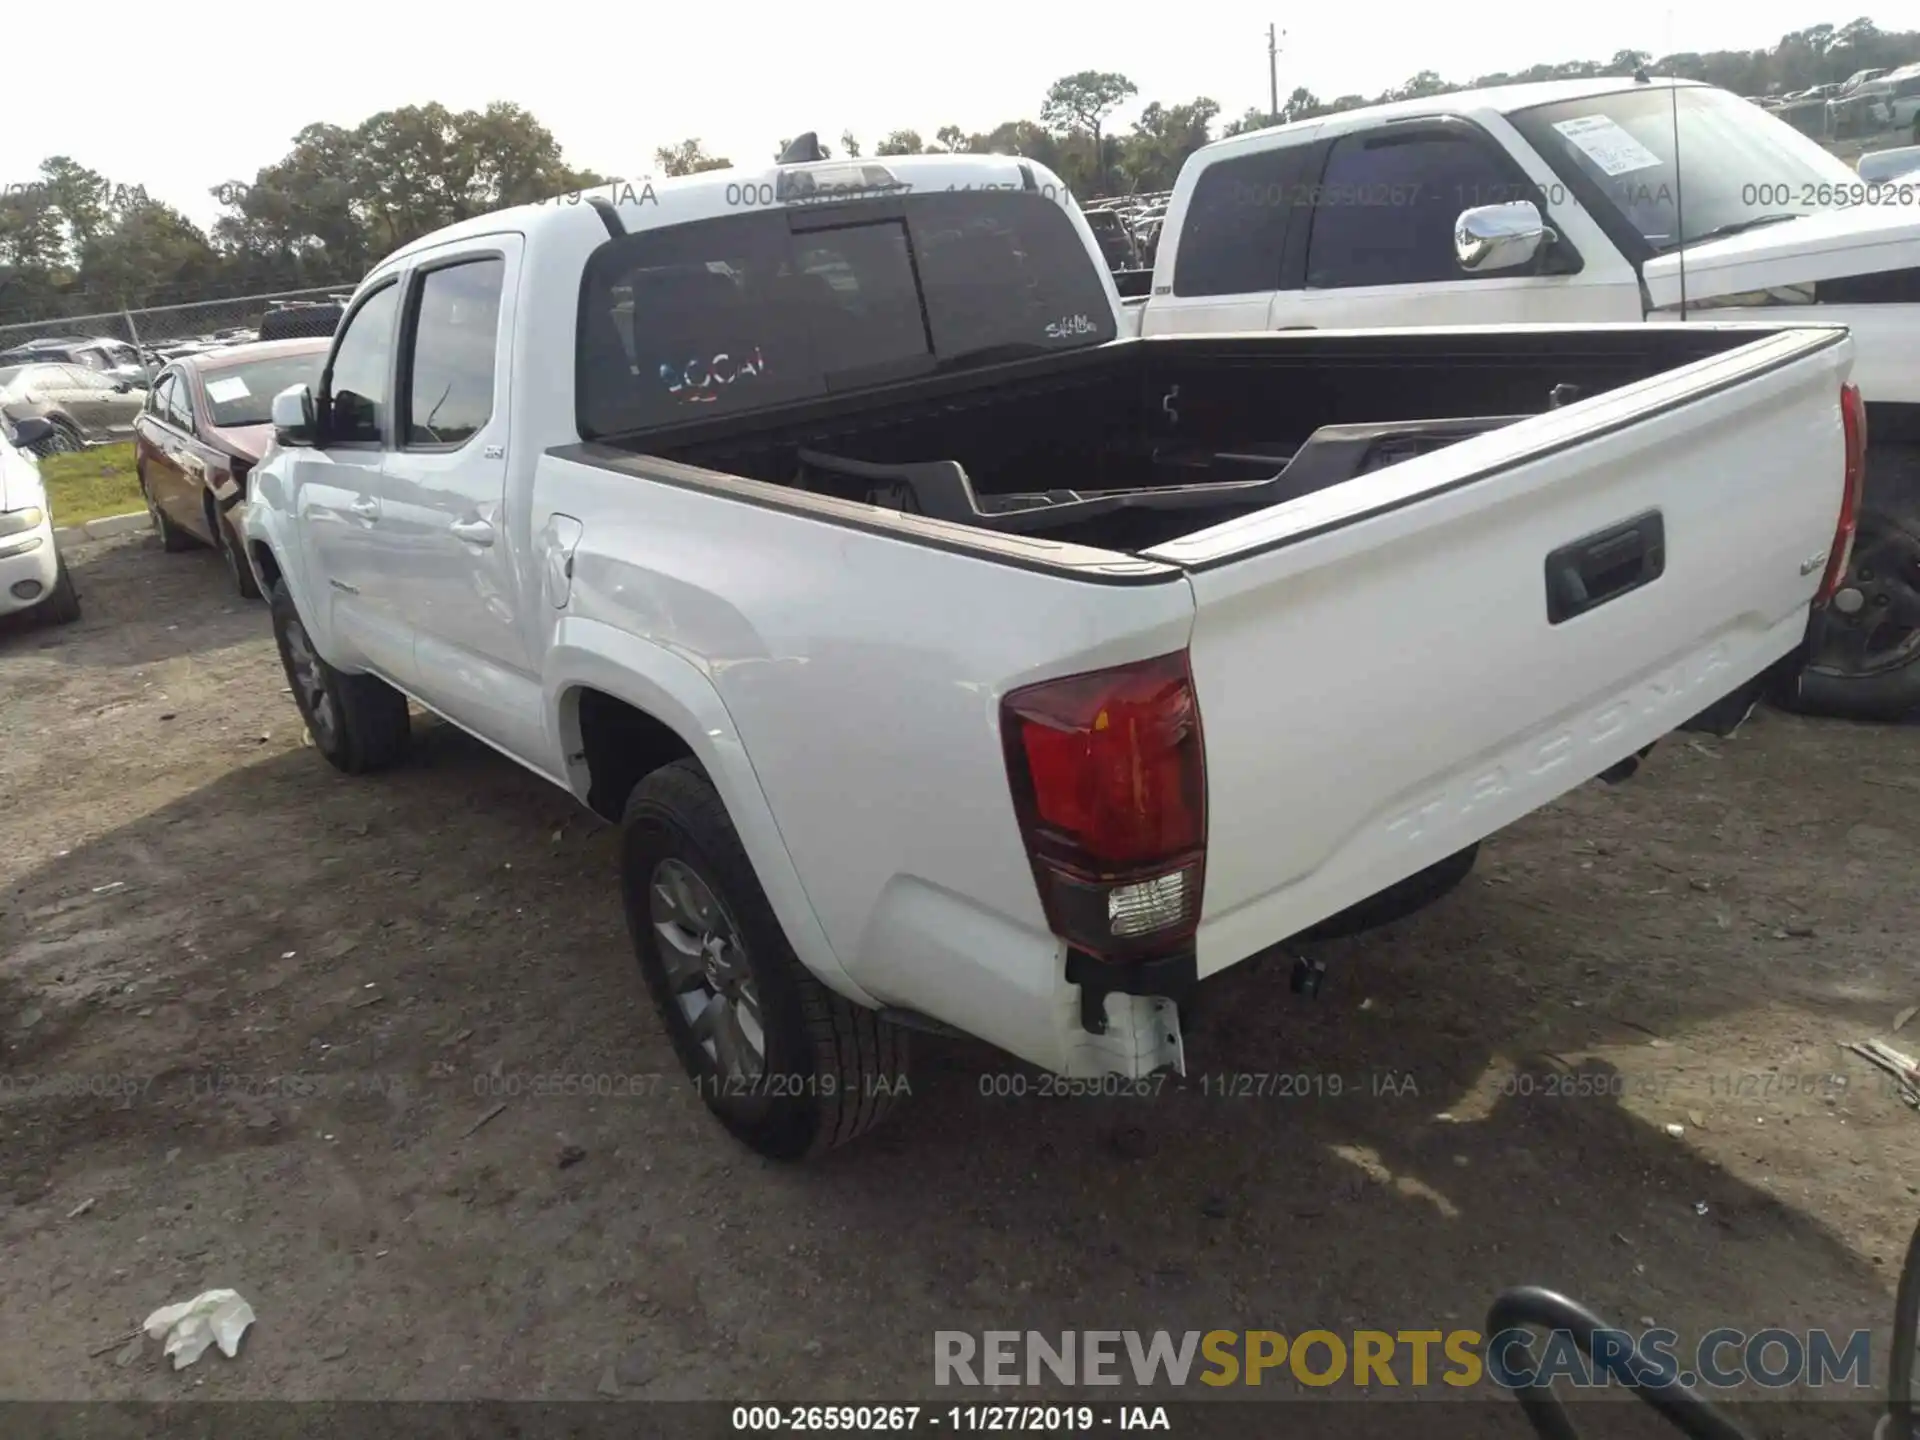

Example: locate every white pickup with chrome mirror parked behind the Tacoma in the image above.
[1127,77,1920,718]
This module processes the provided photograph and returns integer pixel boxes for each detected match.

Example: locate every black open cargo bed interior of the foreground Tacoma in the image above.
[612,326,1797,553]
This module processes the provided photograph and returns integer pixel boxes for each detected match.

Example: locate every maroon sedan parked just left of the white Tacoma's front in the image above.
[132,336,332,599]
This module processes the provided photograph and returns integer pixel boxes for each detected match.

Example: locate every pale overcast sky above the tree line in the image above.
[0,0,1889,225]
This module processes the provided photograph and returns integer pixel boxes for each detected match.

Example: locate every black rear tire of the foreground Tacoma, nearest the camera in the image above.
[620,760,908,1160]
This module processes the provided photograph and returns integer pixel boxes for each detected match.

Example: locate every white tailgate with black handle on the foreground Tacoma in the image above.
[1146,328,1853,975]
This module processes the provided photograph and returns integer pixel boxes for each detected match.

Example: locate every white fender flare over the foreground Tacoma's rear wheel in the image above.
[541,616,879,1010]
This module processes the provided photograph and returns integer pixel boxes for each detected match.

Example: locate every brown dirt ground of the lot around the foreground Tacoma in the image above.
[0,536,1920,1402]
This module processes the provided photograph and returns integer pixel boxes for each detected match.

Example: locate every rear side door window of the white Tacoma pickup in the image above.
[405,255,507,447]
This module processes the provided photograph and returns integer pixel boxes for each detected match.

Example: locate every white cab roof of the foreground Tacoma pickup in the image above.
[374,156,1066,276]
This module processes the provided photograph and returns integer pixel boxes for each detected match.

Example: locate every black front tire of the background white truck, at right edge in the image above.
[1778,442,1920,722]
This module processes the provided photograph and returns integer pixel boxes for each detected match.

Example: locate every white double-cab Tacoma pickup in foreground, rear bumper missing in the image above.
[242,156,1862,1156]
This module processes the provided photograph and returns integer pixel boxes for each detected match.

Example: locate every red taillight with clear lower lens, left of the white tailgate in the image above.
[1000,653,1206,960]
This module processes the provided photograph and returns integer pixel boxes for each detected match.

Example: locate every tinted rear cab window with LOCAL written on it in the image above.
[578,190,1114,436]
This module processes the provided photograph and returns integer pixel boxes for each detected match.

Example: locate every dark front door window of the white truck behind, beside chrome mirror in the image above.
[1308,131,1532,290]
